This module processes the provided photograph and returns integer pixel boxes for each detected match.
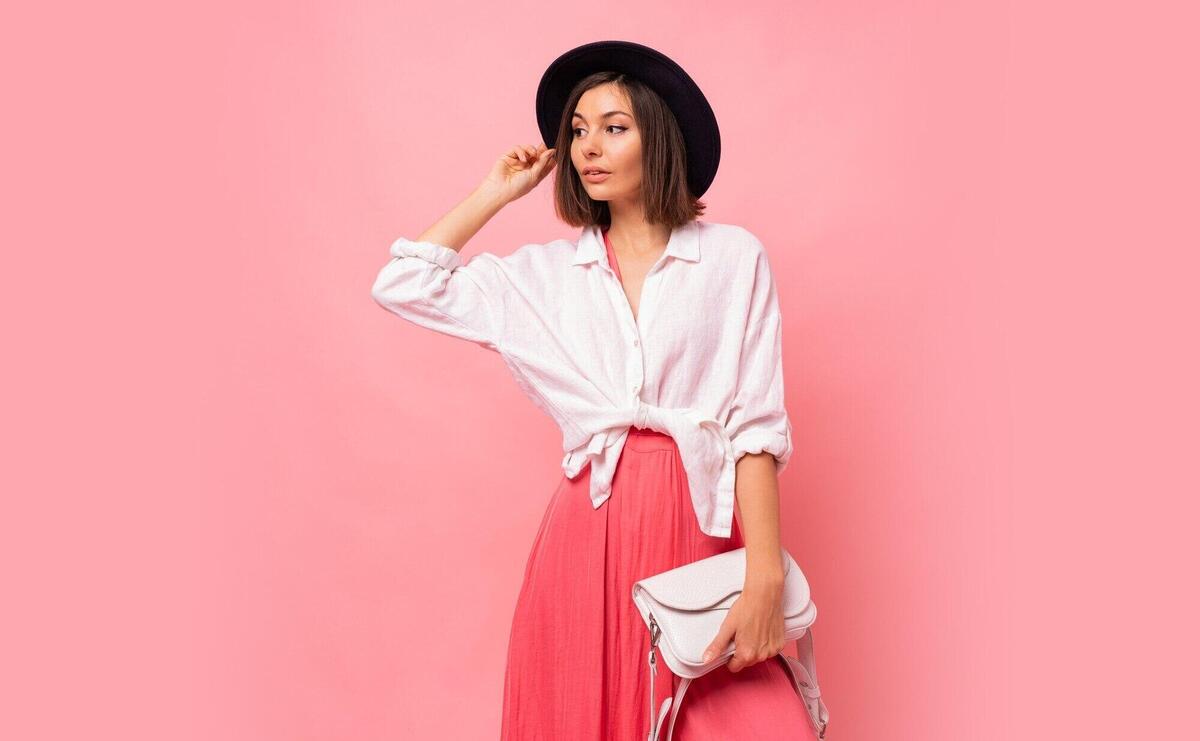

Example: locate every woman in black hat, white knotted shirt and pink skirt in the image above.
[373,42,812,741]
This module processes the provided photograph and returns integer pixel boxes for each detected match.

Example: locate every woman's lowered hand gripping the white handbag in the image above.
[704,579,784,671]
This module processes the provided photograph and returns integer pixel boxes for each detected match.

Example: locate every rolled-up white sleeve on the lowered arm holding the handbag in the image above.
[726,239,792,474]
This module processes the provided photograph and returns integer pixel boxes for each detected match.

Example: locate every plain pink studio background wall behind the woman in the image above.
[0,1,1200,741]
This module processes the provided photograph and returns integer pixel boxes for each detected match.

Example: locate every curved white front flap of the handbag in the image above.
[634,548,811,618]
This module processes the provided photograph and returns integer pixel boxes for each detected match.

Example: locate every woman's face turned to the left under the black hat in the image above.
[571,83,642,201]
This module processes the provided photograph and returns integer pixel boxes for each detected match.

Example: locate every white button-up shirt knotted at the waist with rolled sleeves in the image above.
[371,215,792,537]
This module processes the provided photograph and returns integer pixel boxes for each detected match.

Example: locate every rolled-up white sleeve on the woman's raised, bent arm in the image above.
[371,237,506,350]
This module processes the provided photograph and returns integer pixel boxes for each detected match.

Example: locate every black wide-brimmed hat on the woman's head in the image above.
[536,41,721,198]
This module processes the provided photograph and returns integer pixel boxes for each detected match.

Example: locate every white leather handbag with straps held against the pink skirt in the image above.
[634,548,829,741]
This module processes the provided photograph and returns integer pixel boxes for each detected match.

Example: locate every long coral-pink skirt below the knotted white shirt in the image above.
[500,428,816,741]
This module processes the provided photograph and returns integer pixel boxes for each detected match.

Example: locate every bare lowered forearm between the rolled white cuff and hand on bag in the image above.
[736,452,784,590]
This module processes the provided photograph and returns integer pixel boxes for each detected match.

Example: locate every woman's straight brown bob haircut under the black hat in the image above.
[554,72,704,230]
